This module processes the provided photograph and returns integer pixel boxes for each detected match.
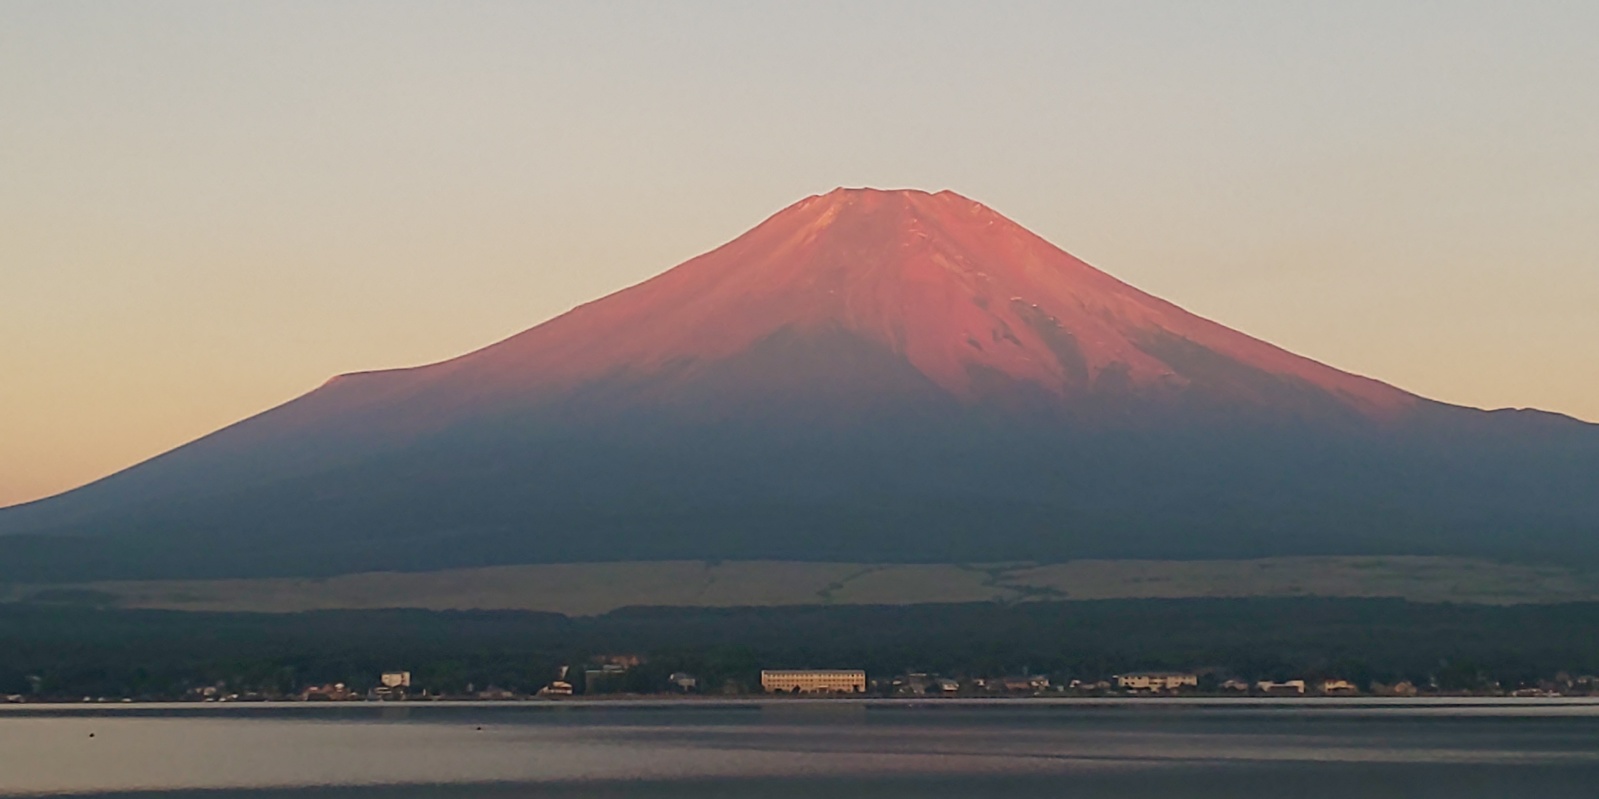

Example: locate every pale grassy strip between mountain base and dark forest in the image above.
[0,558,1599,615]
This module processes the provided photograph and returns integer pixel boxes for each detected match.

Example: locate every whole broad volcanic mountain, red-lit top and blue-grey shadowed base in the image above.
[0,189,1599,577]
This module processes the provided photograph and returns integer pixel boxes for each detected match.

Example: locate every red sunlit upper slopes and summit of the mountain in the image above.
[287,189,1417,437]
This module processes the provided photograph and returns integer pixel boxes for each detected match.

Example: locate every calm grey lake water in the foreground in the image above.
[0,702,1599,799]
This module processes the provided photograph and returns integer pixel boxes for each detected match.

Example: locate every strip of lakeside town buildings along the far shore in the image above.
[0,655,1599,705]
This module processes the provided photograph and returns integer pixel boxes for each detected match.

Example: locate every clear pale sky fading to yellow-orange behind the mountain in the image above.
[0,0,1599,505]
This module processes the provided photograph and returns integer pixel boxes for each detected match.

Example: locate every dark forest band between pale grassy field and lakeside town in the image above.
[0,599,1599,698]
